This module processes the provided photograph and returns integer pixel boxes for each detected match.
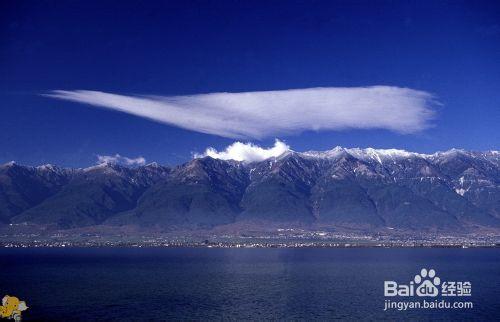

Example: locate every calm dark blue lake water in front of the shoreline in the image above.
[0,248,500,321]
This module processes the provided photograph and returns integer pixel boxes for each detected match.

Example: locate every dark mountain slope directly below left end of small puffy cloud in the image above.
[108,158,248,228]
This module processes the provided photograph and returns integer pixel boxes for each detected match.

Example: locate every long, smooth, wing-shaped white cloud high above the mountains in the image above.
[45,86,436,139]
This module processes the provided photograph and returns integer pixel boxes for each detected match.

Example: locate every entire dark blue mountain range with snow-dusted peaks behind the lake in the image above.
[0,147,500,231]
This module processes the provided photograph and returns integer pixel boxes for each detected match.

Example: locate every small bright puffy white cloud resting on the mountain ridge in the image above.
[194,140,290,162]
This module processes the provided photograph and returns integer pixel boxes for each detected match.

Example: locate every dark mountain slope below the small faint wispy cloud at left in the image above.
[12,164,168,228]
